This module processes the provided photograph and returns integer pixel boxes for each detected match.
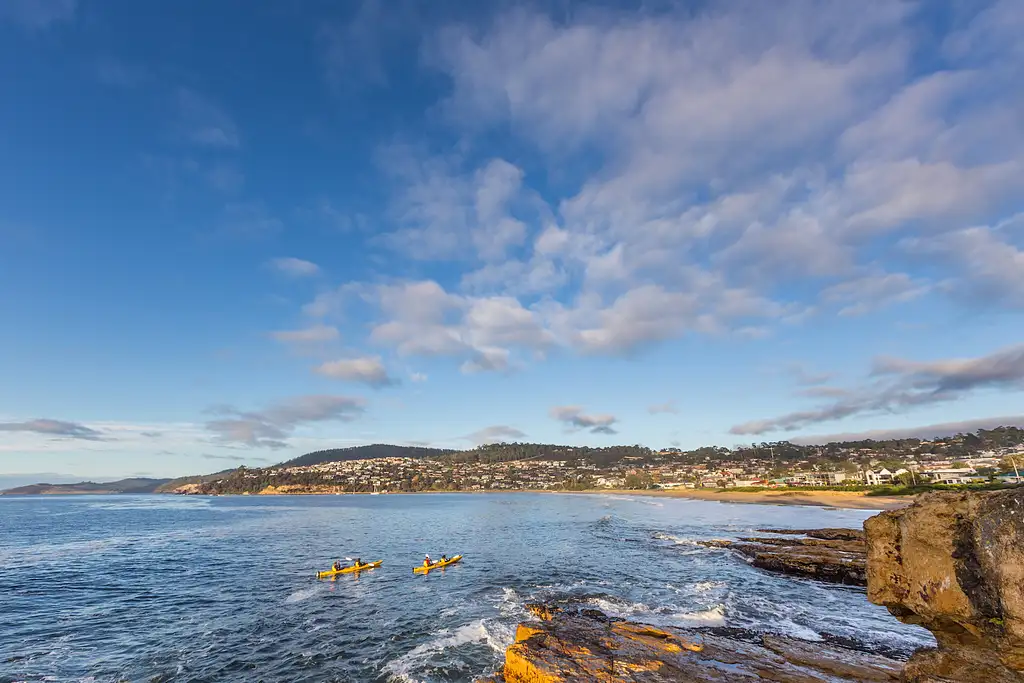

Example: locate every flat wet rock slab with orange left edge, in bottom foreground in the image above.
[484,605,900,683]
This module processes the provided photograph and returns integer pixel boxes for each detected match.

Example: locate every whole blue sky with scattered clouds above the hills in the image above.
[0,0,1024,477]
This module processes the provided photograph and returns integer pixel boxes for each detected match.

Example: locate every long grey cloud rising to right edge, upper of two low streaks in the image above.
[729,345,1024,434]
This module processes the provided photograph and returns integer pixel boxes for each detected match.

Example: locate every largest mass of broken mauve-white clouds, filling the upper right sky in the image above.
[292,0,1024,373]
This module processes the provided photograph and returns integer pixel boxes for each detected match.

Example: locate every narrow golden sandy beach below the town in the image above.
[580,488,913,510]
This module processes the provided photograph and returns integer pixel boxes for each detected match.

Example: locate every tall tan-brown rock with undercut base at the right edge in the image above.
[864,487,1024,683]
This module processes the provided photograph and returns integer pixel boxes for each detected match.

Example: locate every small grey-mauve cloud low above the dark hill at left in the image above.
[206,395,366,449]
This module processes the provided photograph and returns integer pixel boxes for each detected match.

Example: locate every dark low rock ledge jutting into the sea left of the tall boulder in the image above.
[698,528,867,586]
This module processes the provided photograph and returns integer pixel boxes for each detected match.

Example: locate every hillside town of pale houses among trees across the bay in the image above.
[175,430,1024,494]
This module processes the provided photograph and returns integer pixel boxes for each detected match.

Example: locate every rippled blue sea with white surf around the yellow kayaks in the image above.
[0,494,933,683]
